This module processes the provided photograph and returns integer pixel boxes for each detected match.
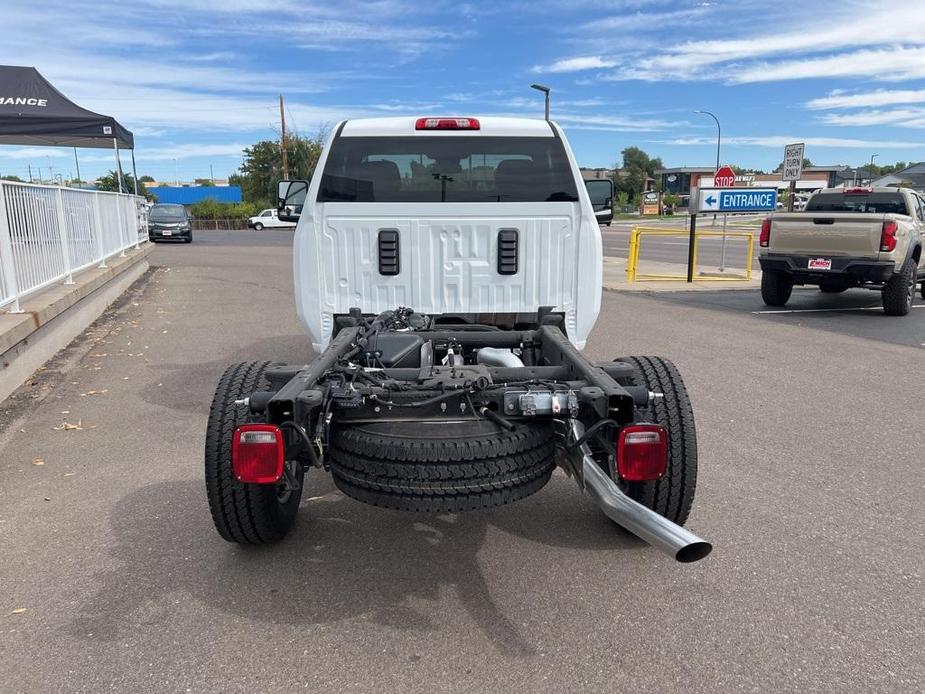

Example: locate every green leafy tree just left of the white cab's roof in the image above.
[236,133,324,207]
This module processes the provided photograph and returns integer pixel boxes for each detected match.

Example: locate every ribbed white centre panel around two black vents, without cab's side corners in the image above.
[320,217,576,313]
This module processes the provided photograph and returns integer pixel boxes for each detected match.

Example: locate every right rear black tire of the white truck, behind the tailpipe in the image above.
[611,357,697,525]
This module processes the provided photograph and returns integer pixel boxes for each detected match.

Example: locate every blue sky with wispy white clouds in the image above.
[0,0,925,180]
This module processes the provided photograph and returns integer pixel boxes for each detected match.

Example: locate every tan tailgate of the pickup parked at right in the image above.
[768,212,885,258]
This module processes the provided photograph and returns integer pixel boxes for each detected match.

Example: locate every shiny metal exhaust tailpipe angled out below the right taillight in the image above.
[572,420,713,562]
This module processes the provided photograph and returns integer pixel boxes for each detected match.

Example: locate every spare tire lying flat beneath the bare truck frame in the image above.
[328,419,555,513]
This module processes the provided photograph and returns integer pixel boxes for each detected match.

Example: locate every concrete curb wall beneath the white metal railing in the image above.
[0,243,154,400]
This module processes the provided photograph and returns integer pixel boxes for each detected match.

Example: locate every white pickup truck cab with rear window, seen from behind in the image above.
[280,117,602,350]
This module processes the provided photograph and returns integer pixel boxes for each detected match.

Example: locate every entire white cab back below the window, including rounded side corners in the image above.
[295,203,601,349]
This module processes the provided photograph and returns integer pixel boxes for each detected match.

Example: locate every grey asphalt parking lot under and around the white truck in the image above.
[0,231,925,693]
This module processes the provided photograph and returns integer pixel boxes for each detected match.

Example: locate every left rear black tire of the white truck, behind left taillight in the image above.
[205,361,304,545]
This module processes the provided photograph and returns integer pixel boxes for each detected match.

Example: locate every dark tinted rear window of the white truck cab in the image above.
[318,135,578,202]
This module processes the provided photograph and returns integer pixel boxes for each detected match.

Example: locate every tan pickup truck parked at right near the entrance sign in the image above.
[758,188,925,316]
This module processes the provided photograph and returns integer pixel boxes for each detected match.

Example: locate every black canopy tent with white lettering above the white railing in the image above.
[0,65,138,193]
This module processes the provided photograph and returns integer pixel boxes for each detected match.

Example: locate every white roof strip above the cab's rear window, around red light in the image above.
[338,114,555,137]
